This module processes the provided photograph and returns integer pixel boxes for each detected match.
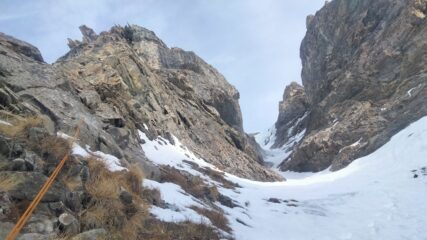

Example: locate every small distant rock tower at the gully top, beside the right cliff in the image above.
[272,82,309,148]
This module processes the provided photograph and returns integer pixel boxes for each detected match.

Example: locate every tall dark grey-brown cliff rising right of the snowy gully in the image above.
[278,0,427,171]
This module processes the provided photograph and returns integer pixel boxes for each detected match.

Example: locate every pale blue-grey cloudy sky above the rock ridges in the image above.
[0,0,325,132]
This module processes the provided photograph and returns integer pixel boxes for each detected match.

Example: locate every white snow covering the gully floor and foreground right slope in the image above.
[141,117,427,240]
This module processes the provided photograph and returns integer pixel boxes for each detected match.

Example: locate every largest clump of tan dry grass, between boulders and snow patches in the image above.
[82,159,149,239]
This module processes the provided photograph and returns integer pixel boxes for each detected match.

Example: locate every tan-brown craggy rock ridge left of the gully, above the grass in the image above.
[0,25,280,181]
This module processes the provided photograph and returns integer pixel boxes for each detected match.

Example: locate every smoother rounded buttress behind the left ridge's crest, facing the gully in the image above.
[124,25,243,131]
